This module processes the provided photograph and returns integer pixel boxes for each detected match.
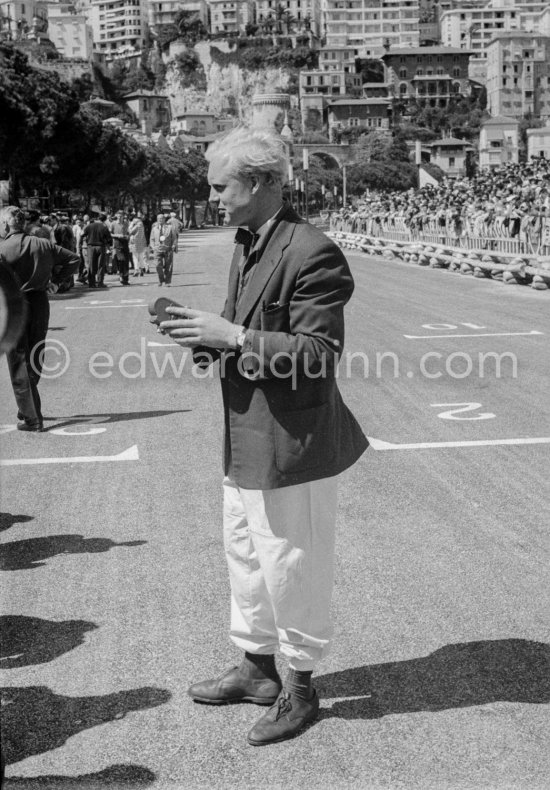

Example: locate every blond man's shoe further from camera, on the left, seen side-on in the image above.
[187,667,282,705]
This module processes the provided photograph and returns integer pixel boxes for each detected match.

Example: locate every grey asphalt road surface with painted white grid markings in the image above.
[0,229,550,790]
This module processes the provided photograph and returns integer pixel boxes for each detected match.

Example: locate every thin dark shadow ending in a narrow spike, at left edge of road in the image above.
[0,535,147,571]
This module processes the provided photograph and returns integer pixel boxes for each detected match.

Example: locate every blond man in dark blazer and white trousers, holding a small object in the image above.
[160,128,368,746]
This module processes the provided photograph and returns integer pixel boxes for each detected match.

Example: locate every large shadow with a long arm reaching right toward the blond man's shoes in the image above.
[0,686,171,768]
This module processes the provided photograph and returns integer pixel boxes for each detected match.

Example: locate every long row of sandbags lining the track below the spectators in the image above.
[327,231,550,291]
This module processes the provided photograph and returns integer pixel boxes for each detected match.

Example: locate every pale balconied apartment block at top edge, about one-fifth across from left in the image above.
[88,0,147,59]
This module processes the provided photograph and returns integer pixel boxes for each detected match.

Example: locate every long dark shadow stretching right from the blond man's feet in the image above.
[315,639,550,719]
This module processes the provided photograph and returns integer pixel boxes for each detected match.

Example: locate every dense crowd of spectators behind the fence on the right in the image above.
[332,157,550,249]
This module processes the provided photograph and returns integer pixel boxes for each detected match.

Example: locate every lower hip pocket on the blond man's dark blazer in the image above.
[275,403,334,474]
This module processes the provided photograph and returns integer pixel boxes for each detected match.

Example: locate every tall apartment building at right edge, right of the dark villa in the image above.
[487,32,550,118]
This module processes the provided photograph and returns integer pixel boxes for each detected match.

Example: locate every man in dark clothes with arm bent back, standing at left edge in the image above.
[0,206,78,431]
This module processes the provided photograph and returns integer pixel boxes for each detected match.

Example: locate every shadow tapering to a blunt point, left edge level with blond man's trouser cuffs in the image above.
[0,614,97,669]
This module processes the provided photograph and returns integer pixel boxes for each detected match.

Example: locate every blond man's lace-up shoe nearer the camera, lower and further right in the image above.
[248,690,319,746]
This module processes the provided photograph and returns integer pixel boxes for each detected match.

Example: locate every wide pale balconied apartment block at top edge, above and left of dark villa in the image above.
[324,0,420,58]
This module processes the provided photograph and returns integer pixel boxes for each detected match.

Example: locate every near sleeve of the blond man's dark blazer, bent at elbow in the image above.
[241,240,354,380]
